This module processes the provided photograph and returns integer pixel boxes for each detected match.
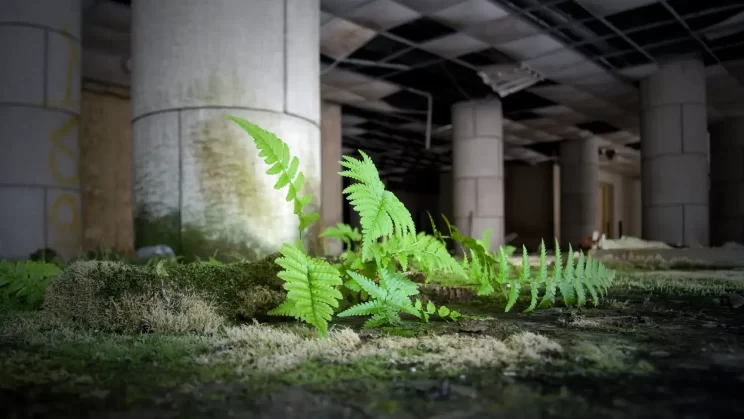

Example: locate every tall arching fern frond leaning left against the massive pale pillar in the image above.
[228,116,320,234]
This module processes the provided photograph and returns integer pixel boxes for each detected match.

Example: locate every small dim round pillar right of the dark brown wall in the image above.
[560,138,599,247]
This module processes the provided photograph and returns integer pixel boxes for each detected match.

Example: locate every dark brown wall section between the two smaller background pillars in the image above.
[504,162,556,250]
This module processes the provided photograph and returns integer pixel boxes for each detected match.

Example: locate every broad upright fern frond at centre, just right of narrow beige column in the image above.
[339,151,416,260]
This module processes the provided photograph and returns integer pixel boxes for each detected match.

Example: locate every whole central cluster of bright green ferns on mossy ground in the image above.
[225,117,614,335]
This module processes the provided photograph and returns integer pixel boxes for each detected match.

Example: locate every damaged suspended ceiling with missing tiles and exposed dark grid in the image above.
[84,0,744,185]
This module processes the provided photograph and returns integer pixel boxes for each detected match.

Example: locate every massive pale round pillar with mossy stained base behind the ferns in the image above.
[132,0,321,256]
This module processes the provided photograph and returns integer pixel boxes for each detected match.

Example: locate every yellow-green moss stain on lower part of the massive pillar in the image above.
[135,115,320,260]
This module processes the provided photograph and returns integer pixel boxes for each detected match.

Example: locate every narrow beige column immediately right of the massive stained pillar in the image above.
[320,102,344,255]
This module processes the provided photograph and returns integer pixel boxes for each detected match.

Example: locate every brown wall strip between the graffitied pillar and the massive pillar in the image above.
[80,82,134,254]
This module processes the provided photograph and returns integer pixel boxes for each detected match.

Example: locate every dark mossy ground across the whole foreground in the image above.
[0,271,744,418]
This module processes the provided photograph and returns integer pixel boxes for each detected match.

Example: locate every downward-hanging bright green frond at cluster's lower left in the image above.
[269,244,343,336]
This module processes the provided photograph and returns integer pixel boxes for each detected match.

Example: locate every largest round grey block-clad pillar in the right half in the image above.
[641,58,709,246]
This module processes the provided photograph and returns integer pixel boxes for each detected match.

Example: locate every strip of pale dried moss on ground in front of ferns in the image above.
[0,313,563,373]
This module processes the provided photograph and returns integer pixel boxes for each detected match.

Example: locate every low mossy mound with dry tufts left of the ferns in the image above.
[43,254,284,333]
